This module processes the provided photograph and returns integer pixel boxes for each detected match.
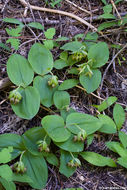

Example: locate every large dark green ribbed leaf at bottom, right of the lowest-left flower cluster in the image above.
[22,152,48,190]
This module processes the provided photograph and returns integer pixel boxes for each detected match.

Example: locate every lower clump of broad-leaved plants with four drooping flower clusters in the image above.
[0,119,116,189]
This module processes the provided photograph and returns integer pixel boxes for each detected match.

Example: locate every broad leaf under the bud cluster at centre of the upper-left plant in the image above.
[33,75,57,107]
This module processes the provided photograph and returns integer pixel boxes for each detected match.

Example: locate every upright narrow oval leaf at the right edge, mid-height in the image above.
[113,104,125,130]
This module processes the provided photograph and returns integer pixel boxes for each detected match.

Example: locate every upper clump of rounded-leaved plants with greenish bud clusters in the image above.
[7,25,109,119]
